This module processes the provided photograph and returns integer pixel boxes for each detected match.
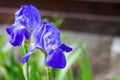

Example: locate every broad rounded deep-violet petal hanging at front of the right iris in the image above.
[46,49,66,68]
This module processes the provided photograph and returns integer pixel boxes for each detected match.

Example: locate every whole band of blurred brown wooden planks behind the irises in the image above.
[0,0,120,36]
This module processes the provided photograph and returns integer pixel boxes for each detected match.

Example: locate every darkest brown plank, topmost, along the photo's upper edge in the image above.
[0,0,120,16]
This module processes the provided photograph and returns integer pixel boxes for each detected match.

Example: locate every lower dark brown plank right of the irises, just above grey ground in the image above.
[60,19,120,36]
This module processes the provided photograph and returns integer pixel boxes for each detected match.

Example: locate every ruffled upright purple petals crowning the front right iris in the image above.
[33,22,62,52]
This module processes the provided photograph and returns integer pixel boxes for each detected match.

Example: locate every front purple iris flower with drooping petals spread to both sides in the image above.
[21,22,72,68]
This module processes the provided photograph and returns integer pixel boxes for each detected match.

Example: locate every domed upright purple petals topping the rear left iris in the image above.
[15,5,41,30]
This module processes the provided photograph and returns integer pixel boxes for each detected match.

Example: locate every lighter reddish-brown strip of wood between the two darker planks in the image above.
[0,7,120,23]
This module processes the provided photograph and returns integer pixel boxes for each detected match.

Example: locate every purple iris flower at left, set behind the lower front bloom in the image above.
[6,5,41,46]
